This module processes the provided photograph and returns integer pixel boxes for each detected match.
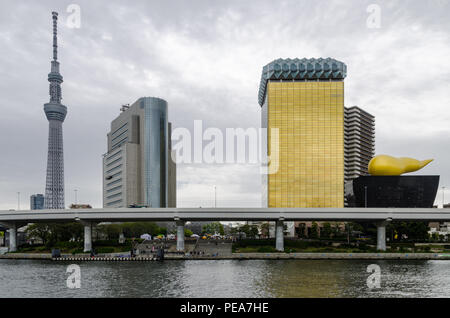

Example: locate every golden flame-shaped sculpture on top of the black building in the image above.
[369,155,433,176]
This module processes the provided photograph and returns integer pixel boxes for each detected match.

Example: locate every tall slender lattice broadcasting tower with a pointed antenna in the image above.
[44,12,67,209]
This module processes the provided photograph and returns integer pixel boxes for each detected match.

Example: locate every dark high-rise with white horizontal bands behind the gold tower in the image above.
[344,106,375,183]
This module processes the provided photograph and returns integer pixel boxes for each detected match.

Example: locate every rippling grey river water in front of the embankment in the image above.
[0,260,450,297]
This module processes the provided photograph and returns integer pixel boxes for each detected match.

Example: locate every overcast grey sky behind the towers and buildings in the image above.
[0,0,450,210]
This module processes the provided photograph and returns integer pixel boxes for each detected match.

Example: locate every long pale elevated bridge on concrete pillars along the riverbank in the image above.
[0,208,450,252]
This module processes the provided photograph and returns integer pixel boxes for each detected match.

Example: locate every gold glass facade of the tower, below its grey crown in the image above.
[265,81,344,208]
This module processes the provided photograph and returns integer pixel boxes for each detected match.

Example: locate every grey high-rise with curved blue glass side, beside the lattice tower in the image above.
[103,97,176,208]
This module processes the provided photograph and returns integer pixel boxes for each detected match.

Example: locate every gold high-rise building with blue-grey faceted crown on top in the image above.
[259,58,347,235]
